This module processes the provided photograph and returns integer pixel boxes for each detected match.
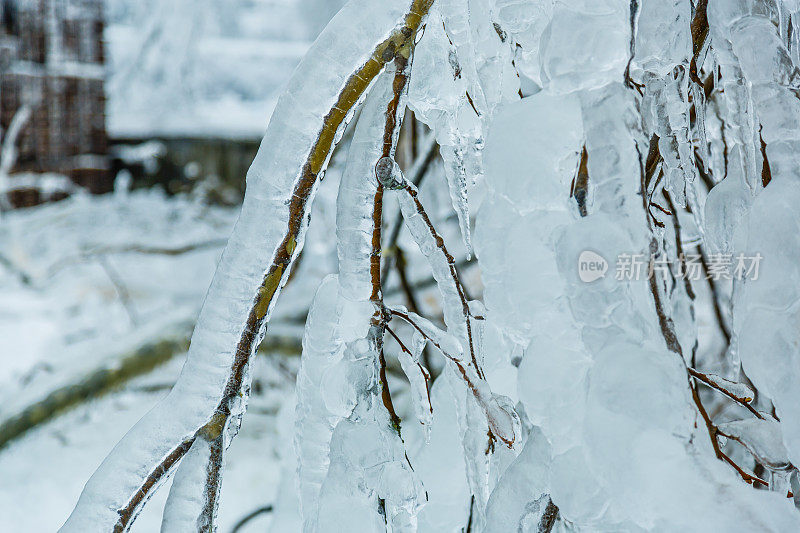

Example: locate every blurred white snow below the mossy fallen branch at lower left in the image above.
[0,348,296,533]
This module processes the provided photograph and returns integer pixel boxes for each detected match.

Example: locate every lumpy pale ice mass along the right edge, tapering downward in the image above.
[707,0,800,470]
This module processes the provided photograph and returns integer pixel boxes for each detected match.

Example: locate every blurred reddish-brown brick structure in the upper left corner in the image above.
[0,0,113,206]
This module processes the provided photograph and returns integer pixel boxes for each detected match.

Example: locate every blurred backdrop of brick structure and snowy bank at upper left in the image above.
[0,0,343,206]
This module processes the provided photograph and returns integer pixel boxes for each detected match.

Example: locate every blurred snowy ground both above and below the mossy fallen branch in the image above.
[0,186,318,532]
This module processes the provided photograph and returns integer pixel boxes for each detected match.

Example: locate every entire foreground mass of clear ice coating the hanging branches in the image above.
[64,0,800,532]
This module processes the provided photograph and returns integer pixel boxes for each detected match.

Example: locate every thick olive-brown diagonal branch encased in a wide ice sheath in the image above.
[63,0,432,531]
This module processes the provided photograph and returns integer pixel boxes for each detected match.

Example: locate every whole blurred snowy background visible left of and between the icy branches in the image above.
[0,0,468,532]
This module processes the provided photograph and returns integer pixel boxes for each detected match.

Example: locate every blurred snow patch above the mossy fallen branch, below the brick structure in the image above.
[0,192,234,418]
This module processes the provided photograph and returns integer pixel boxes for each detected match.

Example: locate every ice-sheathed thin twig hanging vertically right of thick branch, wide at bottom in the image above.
[296,33,424,531]
